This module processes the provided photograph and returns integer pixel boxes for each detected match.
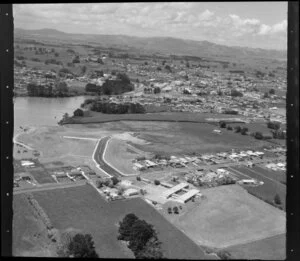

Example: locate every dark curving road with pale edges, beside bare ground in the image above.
[93,136,123,177]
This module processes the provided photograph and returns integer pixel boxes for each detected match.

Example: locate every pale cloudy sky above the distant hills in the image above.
[13,1,287,50]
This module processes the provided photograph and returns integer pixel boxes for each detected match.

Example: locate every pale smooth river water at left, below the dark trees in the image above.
[14,96,90,134]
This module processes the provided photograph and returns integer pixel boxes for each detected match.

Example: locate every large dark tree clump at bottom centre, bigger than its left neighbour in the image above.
[118,214,163,259]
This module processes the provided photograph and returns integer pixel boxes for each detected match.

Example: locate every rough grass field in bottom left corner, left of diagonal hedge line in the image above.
[12,195,55,257]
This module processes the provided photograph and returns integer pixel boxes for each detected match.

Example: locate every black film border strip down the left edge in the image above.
[0,4,14,257]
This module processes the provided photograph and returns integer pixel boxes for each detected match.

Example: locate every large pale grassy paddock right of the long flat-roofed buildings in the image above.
[162,185,286,249]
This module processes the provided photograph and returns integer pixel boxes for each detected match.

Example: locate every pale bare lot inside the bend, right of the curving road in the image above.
[104,139,138,174]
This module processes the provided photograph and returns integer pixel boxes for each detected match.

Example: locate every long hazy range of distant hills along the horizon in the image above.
[14,28,287,60]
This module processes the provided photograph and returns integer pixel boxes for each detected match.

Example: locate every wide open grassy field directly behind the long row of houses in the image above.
[126,122,266,155]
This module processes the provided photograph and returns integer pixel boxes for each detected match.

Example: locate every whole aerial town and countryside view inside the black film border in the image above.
[13,2,287,260]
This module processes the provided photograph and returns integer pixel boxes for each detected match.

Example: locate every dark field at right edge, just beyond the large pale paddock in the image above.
[229,167,286,209]
